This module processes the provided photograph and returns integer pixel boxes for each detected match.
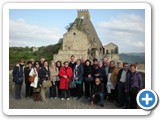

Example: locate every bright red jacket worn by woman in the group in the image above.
[59,66,72,89]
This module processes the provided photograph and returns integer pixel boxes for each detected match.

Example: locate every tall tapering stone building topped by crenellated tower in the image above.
[53,10,103,62]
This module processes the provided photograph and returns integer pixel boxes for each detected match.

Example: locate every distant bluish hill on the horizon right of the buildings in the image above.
[119,53,145,64]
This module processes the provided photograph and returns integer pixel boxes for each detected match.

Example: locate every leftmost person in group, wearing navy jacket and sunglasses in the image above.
[12,60,24,100]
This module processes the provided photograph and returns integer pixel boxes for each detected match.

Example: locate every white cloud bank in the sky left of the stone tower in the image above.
[9,19,62,47]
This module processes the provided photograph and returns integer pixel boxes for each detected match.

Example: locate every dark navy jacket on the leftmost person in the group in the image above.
[12,64,24,84]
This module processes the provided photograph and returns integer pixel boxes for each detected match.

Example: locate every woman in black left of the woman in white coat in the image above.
[24,61,33,99]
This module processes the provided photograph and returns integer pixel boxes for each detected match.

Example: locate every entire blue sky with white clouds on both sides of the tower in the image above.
[9,9,145,53]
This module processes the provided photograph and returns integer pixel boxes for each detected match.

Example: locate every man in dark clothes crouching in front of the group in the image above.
[91,77,104,107]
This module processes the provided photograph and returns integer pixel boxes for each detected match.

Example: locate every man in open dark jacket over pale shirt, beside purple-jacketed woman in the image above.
[116,63,128,107]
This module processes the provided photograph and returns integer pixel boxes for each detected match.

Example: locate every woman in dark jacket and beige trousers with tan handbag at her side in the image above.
[40,60,50,102]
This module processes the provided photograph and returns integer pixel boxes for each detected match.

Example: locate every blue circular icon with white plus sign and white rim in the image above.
[137,89,158,110]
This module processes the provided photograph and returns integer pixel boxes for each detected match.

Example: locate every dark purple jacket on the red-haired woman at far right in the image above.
[125,72,143,92]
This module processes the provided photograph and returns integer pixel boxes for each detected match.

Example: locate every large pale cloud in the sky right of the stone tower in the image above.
[96,14,145,52]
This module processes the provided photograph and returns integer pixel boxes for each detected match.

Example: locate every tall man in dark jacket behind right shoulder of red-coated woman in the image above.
[69,55,77,97]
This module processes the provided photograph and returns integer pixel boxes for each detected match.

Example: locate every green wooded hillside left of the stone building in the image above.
[9,43,62,70]
